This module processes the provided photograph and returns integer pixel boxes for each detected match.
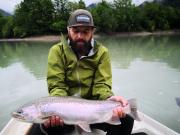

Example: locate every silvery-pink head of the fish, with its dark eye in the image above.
[12,104,41,123]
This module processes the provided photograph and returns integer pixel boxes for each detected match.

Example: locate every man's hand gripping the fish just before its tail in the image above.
[108,96,128,118]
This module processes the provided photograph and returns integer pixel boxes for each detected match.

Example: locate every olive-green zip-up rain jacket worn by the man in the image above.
[47,37,113,100]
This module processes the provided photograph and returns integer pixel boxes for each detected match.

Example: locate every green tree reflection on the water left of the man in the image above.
[0,42,53,78]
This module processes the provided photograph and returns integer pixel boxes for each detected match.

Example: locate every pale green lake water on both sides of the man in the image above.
[0,36,180,133]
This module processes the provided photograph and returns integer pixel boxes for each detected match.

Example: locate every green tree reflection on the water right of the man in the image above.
[101,36,180,70]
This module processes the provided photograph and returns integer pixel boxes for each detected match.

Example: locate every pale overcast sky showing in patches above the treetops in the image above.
[0,0,149,13]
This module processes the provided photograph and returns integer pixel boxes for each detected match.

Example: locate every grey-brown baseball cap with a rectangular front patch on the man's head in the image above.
[68,9,95,27]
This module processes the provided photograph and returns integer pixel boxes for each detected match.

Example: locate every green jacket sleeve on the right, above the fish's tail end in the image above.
[92,49,113,100]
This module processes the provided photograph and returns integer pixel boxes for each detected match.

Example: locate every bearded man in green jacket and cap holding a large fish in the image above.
[44,9,134,135]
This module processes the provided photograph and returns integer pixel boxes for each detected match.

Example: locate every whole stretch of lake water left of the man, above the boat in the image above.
[0,42,53,130]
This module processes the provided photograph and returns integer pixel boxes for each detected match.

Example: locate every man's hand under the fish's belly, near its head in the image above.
[44,116,64,128]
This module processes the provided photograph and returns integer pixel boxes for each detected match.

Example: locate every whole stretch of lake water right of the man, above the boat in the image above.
[101,36,180,133]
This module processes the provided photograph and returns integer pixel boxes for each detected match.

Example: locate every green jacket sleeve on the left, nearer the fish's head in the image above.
[47,45,68,96]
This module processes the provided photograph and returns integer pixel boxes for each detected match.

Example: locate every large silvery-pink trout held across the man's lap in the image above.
[12,96,139,132]
